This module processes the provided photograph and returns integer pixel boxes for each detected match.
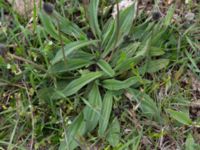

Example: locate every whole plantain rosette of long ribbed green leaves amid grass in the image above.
[39,0,176,150]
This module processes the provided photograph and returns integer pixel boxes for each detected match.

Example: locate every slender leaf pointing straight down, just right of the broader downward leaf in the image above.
[98,91,113,137]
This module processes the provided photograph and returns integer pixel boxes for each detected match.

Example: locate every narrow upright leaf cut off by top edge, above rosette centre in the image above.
[88,0,101,38]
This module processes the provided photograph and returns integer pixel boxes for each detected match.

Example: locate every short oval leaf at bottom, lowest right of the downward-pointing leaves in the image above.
[106,118,120,147]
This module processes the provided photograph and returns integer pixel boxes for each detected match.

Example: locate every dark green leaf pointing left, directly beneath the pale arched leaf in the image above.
[48,59,92,74]
